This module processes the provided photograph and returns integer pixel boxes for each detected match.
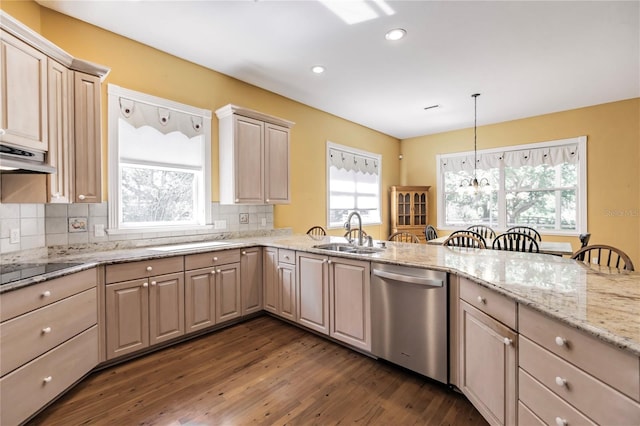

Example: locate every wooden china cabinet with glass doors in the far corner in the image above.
[389,186,431,242]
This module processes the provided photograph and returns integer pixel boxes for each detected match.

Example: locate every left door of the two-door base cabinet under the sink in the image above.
[296,252,329,334]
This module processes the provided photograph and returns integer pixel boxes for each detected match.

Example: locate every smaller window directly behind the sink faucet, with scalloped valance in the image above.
[327,142,382,228]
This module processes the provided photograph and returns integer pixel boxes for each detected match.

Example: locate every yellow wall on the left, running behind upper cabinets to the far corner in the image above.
[0,1,400,238]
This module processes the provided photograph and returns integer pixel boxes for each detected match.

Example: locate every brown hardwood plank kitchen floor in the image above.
[29,316,486,426]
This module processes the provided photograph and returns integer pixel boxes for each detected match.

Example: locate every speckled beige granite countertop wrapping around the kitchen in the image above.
[1,235,640,356]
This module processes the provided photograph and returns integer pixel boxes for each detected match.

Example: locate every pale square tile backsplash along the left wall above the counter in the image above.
[0,203,273,253]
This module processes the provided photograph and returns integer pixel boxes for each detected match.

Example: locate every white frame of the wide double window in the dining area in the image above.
[436,136,587,236]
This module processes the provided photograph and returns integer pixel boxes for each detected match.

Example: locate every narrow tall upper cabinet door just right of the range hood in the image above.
[47,59,74,203]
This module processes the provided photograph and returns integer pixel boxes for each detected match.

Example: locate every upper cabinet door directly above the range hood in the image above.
[0,31,49,151]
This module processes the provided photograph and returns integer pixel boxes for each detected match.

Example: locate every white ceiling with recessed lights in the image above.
[38,0,640,139]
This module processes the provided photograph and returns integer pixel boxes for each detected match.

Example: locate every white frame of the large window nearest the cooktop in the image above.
[107,84,212,234]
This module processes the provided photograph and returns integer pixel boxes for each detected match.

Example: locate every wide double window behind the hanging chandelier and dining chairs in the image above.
[437,136,587,235]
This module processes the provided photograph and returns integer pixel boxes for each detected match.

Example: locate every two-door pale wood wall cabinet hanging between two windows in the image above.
[216,104,294,204]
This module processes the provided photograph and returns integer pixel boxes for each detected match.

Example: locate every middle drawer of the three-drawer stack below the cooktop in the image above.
[0,287,98,376]
